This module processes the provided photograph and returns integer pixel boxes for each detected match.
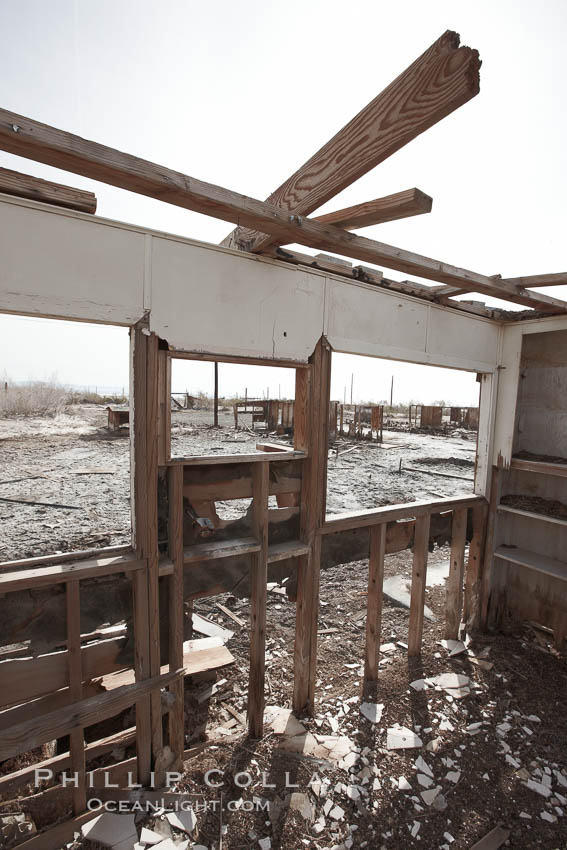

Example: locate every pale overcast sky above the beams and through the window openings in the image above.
[0,0,567,404]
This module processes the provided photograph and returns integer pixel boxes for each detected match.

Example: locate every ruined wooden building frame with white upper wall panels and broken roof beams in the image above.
[0,33,567,850]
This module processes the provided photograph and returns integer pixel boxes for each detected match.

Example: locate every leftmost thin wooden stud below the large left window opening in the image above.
[65,580,87,815]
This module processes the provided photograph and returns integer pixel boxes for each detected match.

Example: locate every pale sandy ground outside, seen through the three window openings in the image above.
[0,405,475,560]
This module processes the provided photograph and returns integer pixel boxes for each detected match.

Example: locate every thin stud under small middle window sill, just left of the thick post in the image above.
[248,461,270,738]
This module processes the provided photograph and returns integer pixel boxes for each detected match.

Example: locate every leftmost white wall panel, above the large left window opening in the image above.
[0,195,148,325]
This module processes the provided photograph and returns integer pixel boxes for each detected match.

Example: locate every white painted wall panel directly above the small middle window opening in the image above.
[150,237,325,362]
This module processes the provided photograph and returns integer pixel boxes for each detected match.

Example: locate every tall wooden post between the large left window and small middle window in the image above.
[130,328,151,785]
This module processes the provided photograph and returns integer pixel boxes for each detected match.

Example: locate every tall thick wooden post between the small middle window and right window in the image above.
[293,337,331,712]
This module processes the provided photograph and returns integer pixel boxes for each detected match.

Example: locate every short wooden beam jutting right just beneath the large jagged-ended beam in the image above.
[313,189,433,230]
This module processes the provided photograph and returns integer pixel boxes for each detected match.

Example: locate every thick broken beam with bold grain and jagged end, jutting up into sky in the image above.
[221,31,480,252]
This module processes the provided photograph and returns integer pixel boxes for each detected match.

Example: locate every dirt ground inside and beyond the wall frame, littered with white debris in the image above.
[0,408,567,850]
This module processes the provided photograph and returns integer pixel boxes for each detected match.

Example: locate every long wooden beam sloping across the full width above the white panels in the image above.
[0,109,567,313]
